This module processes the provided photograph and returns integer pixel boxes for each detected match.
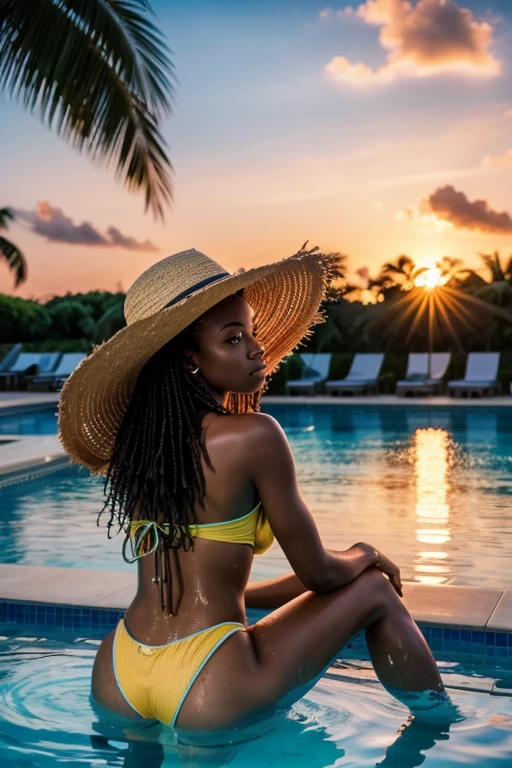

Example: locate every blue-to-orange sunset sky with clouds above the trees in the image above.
[0,0,512,298]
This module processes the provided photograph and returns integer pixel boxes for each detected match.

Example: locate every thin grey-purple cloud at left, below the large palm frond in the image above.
[15,200,159,252]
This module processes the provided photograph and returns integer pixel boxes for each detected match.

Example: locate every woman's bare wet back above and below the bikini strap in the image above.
[126,413,259,645]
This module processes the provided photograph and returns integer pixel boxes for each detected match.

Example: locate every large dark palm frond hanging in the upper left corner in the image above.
[0,0,173,218]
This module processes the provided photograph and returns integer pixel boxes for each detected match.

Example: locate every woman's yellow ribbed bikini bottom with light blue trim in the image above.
[113,619,245,725]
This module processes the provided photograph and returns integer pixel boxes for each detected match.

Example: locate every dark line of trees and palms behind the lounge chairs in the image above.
[0,252,512,353]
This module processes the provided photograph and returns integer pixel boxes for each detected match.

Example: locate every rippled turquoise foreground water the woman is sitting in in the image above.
[0,627,512,768]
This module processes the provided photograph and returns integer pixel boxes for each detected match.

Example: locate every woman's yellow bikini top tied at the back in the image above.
[123,501,274,562]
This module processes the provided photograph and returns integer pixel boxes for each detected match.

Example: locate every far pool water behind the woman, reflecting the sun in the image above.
[0,404,512,589]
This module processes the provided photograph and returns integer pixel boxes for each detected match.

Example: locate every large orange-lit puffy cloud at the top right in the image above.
[320,0,501,86]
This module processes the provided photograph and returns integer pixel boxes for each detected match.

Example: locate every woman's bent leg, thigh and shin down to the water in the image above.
[179,568,443,728]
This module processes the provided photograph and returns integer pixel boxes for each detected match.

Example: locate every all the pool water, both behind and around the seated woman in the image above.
[0,404,512,768]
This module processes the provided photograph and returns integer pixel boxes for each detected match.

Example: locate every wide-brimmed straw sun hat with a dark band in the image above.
[59,249,335,474]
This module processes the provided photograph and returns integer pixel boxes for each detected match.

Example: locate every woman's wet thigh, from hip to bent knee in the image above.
[178,568,403,729]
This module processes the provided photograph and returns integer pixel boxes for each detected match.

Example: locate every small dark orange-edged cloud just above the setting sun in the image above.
[396,184,512,234]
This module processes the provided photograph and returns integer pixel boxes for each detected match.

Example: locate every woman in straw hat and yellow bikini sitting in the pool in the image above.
[59,249,450,730]
